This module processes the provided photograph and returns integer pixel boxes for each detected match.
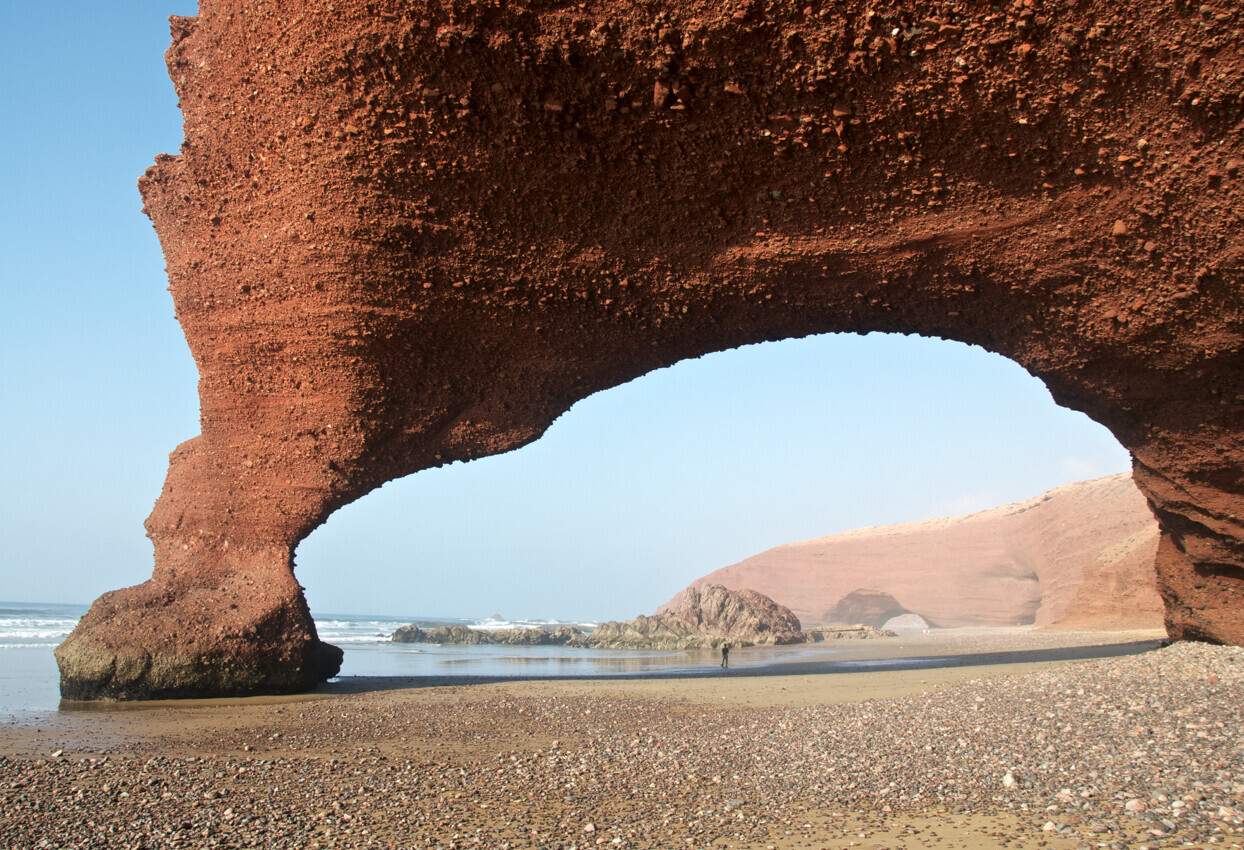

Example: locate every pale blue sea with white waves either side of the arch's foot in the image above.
[0,601,717,721]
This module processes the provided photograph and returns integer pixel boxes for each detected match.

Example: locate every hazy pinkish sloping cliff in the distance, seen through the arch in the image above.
[693,474,1162,628]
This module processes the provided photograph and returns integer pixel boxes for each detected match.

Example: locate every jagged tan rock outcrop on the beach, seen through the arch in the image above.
[587,585,805,650]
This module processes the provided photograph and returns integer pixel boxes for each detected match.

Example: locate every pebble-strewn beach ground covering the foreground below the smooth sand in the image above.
[0,645,1244,850]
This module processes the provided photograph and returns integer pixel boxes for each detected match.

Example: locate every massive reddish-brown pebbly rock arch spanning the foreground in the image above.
[57,0,1244,697]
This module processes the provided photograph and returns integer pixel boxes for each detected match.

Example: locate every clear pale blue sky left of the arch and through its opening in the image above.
[0,0,1128,619]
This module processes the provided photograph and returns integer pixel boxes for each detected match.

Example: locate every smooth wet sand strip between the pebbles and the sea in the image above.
[0,627,1166,754]
